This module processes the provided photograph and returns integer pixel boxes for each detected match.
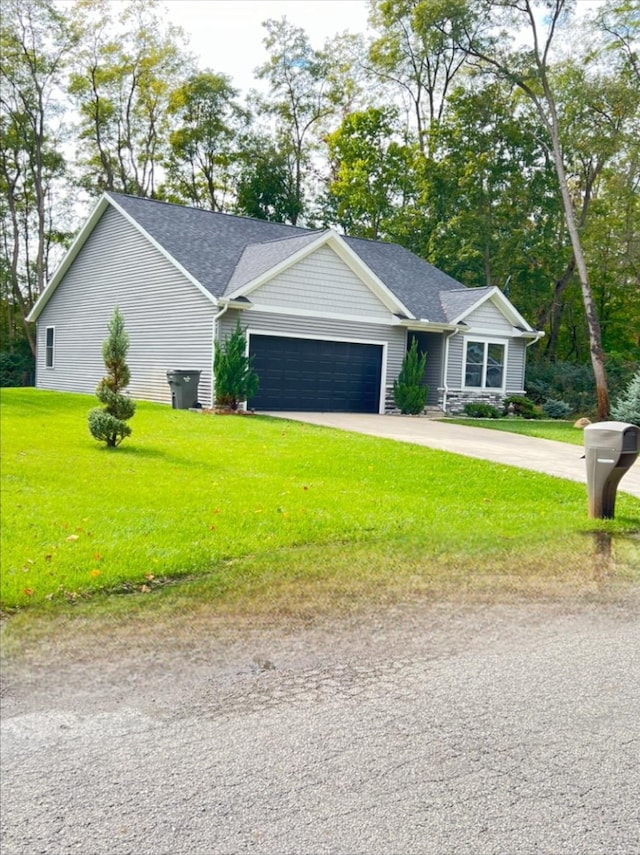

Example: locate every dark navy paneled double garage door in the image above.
[249,335,382,413]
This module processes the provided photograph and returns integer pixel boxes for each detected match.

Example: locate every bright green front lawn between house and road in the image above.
[2,389,640,615]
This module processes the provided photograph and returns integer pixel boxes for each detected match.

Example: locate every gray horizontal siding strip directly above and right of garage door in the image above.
[220,309,406,385]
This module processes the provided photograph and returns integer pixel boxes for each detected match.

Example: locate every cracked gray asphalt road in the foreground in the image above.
[1,597,640,855]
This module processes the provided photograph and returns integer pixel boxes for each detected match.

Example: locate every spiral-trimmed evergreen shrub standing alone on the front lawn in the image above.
[89,306,136,448]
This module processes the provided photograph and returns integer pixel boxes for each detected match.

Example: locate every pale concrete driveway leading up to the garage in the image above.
[265,413,640,498]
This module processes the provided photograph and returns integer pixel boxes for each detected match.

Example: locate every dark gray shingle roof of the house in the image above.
[108,193,479,323]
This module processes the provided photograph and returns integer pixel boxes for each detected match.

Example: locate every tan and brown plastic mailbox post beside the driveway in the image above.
[584,422,640,519]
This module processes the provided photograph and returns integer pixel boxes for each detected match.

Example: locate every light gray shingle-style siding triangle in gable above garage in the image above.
[250,246,392,322]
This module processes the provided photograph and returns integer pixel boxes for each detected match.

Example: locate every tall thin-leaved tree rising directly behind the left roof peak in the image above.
[70,0,191,196]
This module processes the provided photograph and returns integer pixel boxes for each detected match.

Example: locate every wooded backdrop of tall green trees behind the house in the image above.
[0,0,640,415]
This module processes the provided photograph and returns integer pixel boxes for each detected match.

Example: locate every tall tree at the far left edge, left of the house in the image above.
[0,0,74,353]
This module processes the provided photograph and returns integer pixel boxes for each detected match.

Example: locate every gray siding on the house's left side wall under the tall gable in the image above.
[36,208,217,406]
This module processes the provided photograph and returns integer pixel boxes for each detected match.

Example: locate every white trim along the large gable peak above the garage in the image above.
[225,229,414,318]
